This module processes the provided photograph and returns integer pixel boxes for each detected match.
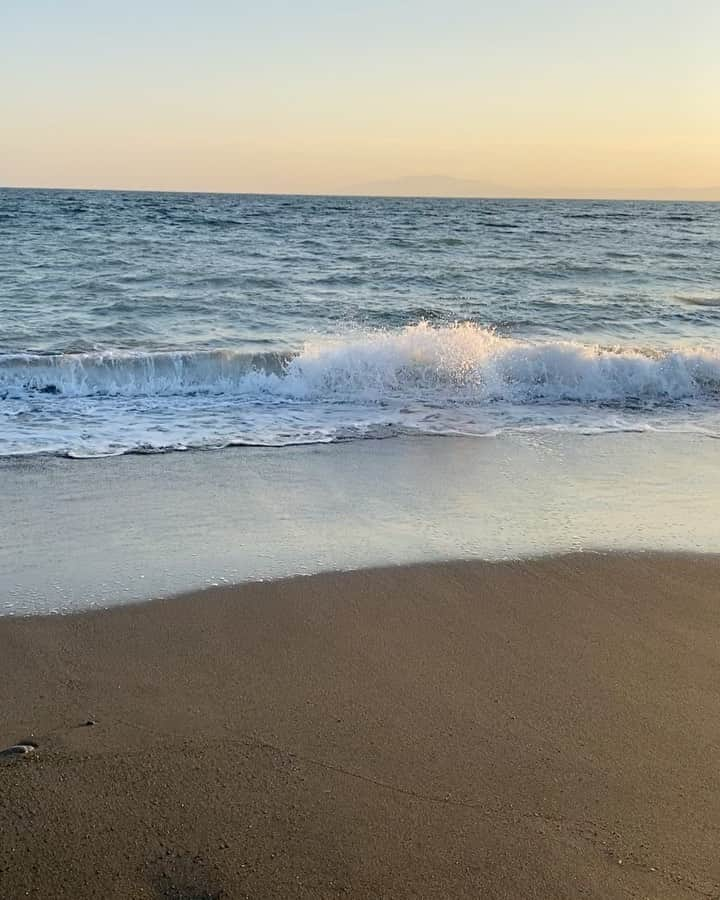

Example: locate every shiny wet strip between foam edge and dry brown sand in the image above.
[0,434,720,615]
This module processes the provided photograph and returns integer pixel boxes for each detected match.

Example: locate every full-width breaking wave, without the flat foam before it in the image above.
[0,323,720,405]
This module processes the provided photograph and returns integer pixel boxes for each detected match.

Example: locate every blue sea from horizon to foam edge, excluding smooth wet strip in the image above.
[0,189,720,458]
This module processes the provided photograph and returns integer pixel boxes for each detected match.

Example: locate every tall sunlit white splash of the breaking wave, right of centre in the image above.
[272,323,720,403]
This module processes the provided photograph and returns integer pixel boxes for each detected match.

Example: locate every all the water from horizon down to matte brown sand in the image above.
[0,190,720,615]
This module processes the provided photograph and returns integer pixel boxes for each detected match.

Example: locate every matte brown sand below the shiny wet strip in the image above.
[0,555,720,900]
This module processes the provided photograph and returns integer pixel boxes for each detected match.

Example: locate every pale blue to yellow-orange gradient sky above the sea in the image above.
[0,0,720,199]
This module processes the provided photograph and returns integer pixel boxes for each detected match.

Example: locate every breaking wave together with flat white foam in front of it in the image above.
[0,323,720,456]
